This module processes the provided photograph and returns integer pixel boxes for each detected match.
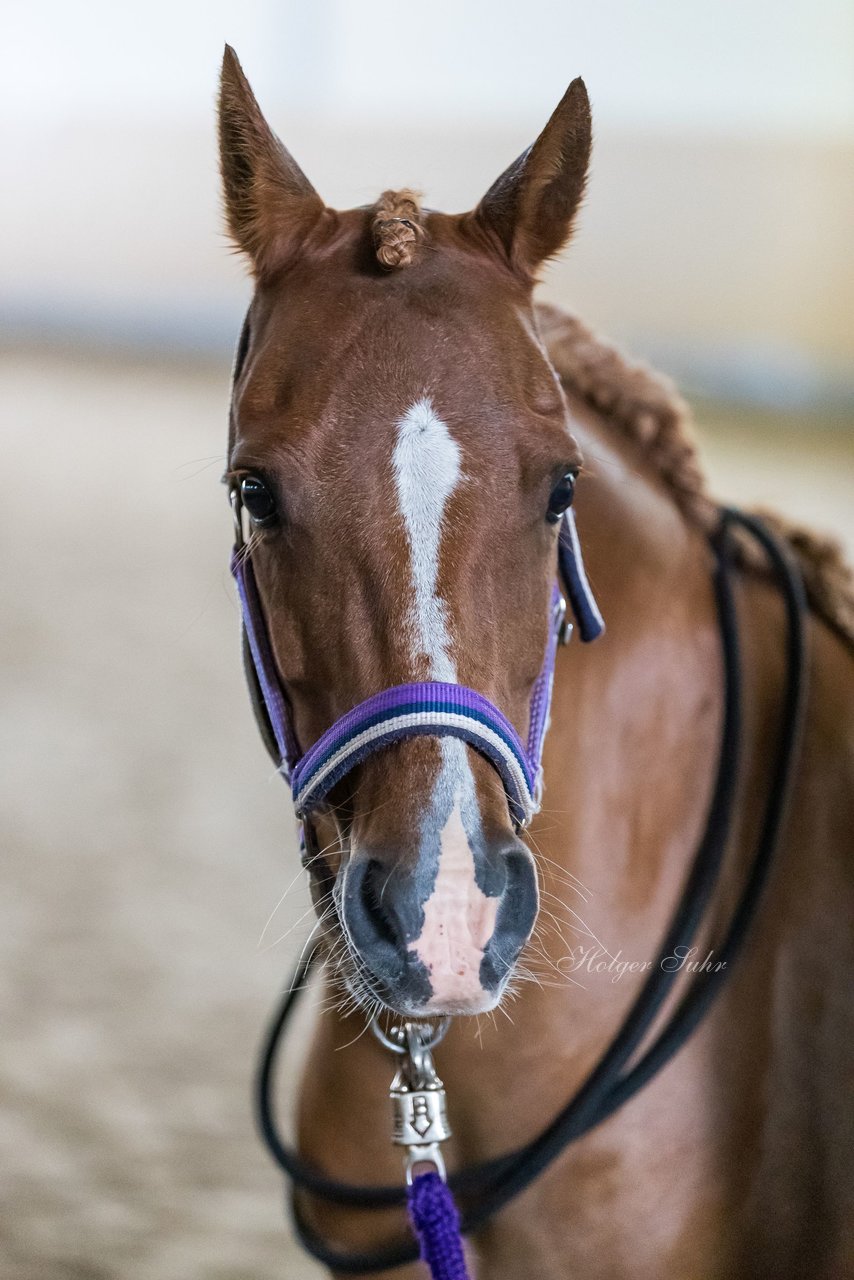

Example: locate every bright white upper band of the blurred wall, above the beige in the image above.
[6,0,854,131]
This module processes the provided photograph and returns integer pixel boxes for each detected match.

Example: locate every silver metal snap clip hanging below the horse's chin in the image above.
[371,1018,451,1183]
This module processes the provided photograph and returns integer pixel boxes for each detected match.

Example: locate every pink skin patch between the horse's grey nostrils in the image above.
[412,804,498,1007]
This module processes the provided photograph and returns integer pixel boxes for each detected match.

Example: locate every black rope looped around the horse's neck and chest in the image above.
[256,508,807,1275]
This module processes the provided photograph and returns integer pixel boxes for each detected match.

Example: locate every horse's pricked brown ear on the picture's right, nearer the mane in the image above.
[475,78,593,276]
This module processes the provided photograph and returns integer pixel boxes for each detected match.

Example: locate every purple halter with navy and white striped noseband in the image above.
[230,488,604,827]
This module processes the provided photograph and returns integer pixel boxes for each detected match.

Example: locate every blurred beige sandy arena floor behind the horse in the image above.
[0,352,854,1280]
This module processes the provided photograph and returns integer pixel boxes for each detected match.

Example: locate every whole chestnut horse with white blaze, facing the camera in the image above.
[219,47,854,1280]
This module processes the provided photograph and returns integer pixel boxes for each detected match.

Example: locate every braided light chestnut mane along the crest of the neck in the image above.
[538,305,854,648]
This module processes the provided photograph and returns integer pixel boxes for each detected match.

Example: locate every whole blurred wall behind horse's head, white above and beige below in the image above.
[0,0,854,403]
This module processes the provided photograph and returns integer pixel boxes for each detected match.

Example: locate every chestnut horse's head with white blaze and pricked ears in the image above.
[219,50,590,1016]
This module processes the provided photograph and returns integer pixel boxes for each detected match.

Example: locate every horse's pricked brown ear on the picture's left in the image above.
[219,45,324,276]
